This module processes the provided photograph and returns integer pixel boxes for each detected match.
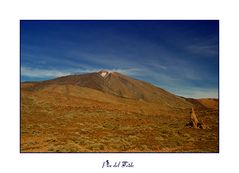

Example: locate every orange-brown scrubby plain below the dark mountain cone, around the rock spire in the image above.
[21,84,219,152]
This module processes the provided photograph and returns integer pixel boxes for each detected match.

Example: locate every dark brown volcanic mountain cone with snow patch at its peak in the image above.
[23,70,192,108]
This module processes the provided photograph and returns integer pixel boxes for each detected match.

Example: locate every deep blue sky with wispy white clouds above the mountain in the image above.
[20,20,219,98]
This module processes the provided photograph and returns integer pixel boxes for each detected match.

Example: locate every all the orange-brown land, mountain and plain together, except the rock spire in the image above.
[20,71,219,152]
